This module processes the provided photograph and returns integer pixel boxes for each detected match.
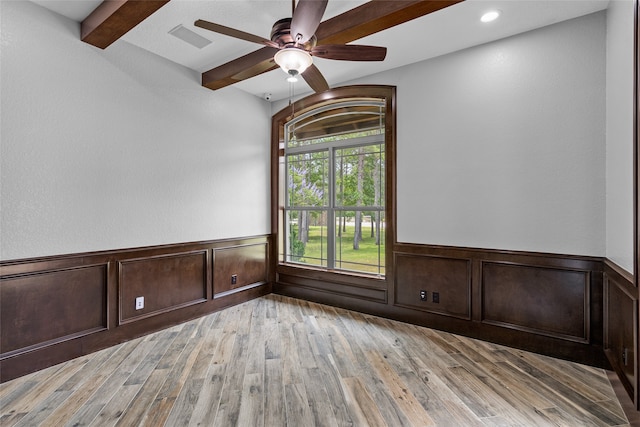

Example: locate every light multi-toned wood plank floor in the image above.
[0,295,628,427]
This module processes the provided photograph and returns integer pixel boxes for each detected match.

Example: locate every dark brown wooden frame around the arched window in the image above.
[271,85,396,288]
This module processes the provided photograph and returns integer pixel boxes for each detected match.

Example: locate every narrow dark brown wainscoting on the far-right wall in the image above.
[604,260,638,407]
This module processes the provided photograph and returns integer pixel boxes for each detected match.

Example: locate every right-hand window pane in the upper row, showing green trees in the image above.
[335,144,385,207]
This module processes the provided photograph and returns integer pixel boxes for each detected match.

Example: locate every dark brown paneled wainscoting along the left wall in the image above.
[0,236,271,382]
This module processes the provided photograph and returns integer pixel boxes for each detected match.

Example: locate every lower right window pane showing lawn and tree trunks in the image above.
[335,210,385,275]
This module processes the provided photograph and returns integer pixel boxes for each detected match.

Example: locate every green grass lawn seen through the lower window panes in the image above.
[300,224,384,274]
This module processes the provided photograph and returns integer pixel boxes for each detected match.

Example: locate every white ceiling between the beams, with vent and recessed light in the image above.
[34,0,608,101]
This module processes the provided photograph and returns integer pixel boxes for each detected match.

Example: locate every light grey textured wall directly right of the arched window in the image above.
[354,13,605,256]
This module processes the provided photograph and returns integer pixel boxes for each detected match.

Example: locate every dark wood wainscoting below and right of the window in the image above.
[274,243,609,367]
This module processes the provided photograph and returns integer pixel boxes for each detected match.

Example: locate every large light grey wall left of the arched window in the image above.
[0,0,270,260]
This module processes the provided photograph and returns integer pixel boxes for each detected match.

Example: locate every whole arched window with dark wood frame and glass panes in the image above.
[272,86,395,279]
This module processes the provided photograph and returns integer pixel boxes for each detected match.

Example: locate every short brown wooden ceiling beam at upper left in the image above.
[80,0,169,49]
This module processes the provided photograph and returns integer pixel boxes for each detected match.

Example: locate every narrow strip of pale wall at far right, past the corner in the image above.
[607,0,633,273]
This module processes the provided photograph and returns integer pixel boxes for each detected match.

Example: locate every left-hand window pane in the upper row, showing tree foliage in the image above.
[287,151,329,207]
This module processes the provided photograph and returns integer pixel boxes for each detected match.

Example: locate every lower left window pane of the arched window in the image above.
[286,210,327,267]
